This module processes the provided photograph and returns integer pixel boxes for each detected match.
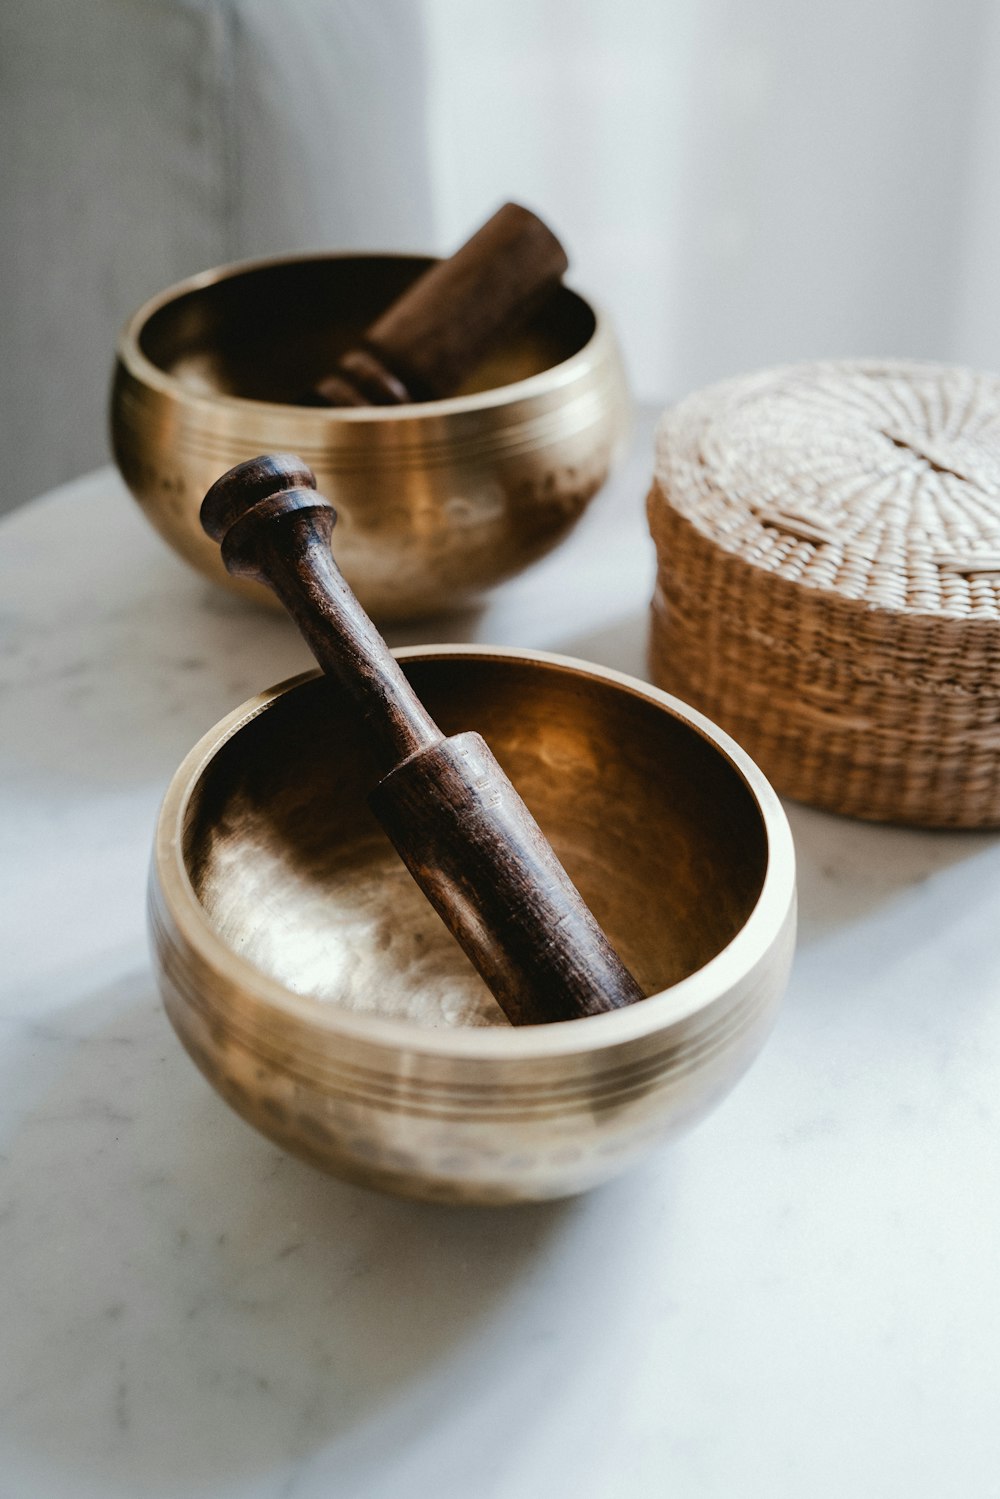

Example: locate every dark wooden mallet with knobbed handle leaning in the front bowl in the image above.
[201,454,643,1025]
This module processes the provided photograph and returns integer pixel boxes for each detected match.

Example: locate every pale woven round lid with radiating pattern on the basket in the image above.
[651,360,1000,621]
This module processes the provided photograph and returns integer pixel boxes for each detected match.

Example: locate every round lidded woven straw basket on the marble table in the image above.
[649,360,1000,827]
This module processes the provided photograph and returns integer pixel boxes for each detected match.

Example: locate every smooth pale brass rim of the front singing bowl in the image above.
[150,643,796,1061]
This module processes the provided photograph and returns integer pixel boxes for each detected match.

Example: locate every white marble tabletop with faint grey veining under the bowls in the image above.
[0,423,1000,1499]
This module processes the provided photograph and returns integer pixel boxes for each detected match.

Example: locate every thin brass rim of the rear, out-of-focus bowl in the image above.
[115,250,613,427]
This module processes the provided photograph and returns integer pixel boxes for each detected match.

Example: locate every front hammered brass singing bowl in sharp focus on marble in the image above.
[150,646,795,1202]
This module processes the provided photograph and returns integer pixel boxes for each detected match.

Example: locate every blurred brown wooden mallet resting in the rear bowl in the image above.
[306,202,570,406]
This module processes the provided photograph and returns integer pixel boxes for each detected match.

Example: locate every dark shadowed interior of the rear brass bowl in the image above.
[139,255,595,402]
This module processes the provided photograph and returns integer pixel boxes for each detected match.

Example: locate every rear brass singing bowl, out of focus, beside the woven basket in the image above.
[111,255,630,621]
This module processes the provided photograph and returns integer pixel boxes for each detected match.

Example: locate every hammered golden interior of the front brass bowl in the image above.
[183,657,768,1025]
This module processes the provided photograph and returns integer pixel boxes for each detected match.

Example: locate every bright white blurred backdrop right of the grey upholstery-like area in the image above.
[424,0,1000,399]
